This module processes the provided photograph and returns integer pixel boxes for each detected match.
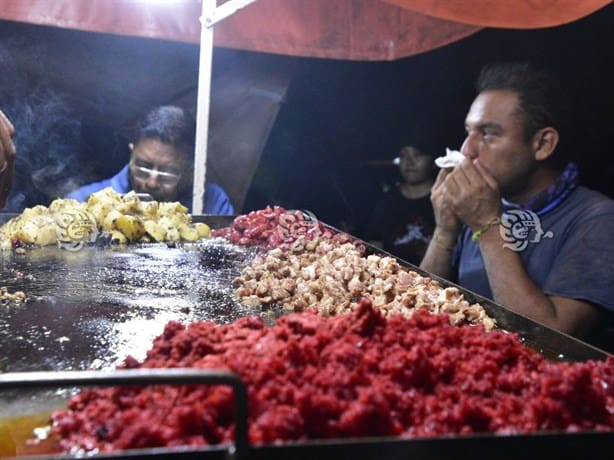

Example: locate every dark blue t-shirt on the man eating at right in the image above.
[455,187,614,348]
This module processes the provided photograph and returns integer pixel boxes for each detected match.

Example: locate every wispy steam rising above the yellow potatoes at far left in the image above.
[0,39,87,213]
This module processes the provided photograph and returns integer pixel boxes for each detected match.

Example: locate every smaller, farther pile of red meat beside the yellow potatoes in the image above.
[212,206,364,249]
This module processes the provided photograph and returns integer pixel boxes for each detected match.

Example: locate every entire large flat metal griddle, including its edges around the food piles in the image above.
[0,216,613,459]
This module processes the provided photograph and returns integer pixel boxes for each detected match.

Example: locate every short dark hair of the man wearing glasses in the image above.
[133,105,196,159]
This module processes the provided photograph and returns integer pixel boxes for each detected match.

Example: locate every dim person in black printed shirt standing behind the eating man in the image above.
[367,145,436,265]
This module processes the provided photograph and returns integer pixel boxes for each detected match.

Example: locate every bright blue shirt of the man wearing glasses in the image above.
[66,165,234,215]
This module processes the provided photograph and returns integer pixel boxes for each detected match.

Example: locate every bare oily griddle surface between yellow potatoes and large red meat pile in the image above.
[0,240,256,372]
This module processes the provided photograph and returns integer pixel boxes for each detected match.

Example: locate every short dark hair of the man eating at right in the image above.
[476,62,569,142]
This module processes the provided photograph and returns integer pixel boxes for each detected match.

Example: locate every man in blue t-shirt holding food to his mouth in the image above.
[420,59,614,351]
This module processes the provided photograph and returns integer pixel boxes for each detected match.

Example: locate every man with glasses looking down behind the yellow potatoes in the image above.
[66,106,234,215]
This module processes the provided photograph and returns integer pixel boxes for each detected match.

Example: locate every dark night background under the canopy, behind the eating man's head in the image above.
[244,4,614,237]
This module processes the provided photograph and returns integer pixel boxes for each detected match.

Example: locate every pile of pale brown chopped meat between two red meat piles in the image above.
[233,238,495,330]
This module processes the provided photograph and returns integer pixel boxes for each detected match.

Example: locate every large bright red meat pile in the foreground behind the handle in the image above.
[53,300,614,451]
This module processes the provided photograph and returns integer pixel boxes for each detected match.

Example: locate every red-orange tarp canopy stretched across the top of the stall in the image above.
[0,0,610,60]
